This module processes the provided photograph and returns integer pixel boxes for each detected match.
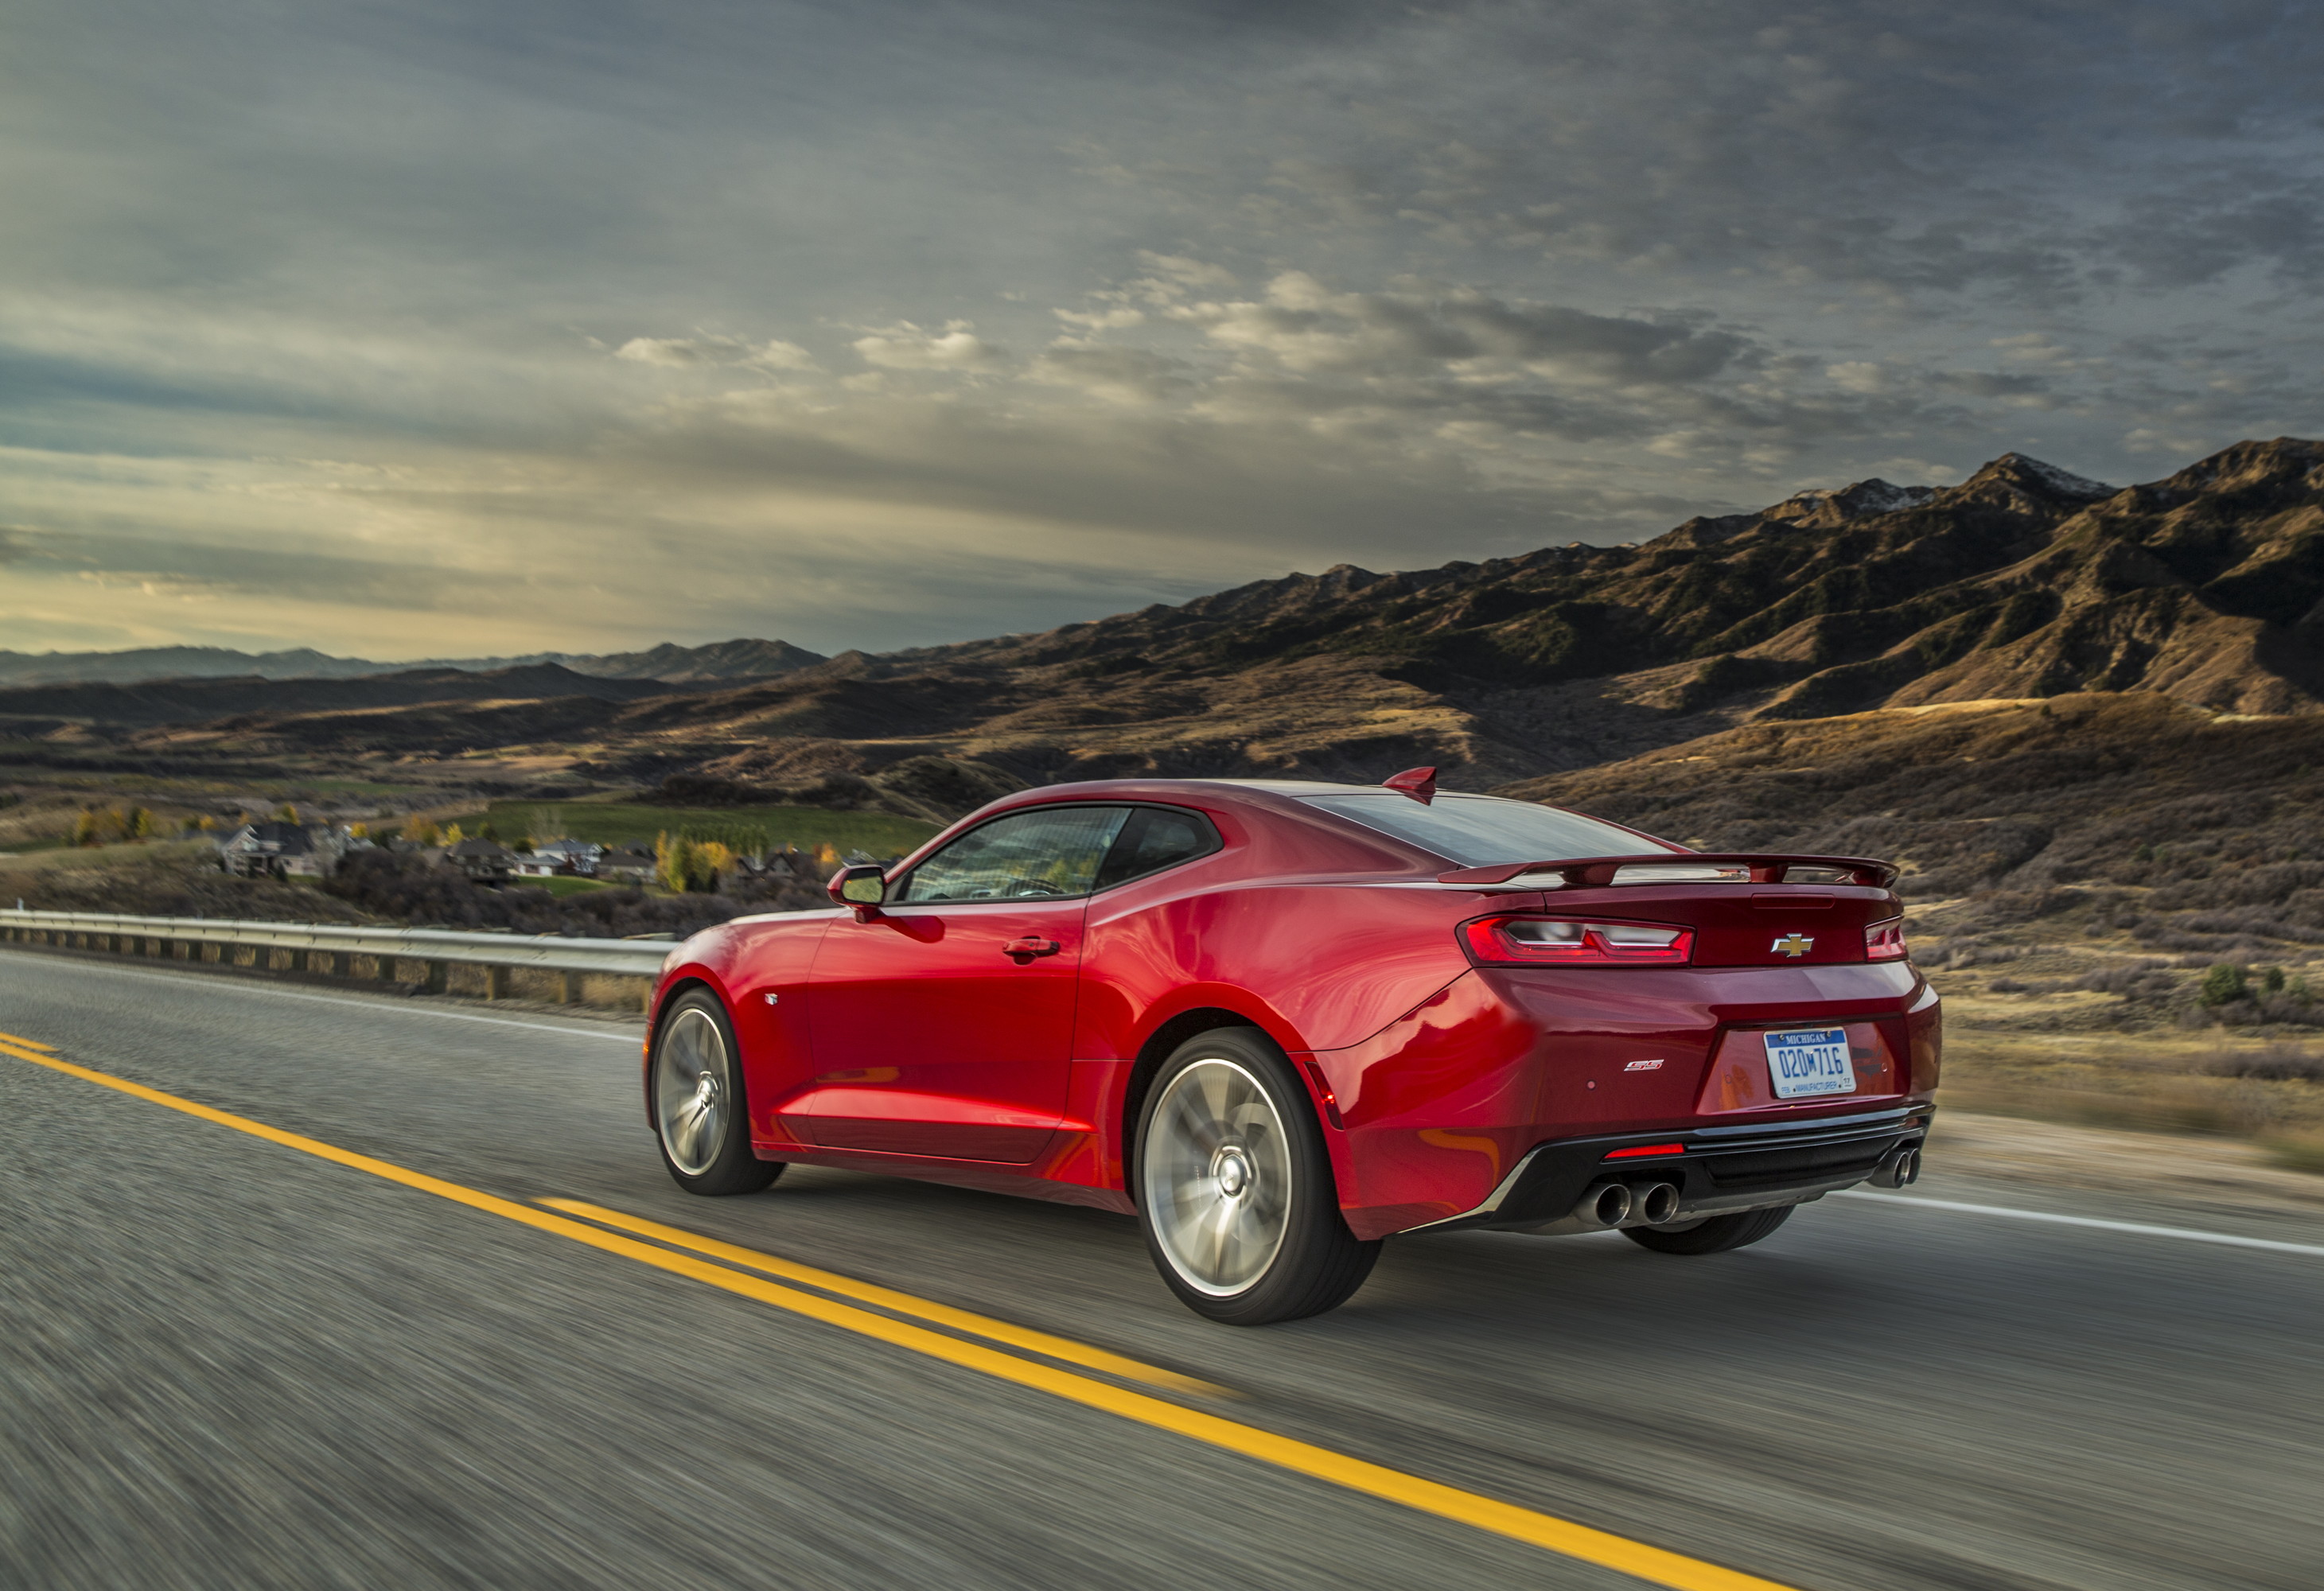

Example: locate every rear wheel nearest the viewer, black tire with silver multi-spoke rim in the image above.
[1130,1027,1380,1326]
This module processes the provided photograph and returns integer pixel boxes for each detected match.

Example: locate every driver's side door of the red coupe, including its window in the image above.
[804,806,1130,1166]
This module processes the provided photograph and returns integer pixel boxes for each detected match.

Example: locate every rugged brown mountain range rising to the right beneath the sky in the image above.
[0,437,2324,799]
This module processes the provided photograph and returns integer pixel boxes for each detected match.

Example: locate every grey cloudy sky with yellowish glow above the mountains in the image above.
[0,0,2324,657]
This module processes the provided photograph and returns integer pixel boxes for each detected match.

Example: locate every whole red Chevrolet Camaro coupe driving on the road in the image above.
[646,768,1938,1324]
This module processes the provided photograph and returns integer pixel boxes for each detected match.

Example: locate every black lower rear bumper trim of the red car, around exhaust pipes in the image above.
[1411,1103,1933,1233]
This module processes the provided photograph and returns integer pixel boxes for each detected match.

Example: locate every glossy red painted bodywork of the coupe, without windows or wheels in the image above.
[658,780,1941,1238]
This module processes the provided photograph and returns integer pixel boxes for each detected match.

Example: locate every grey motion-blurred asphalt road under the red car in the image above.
[0,950,2324,1591]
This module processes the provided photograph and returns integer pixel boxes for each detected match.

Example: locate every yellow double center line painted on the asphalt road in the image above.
[0,1033,1789,1591]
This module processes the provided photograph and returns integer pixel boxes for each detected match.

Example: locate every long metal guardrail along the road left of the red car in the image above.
[0,908,672,1001]
